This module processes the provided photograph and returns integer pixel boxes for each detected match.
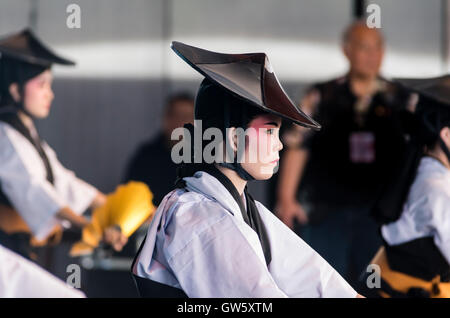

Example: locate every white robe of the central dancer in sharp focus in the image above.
[133,171,357,298]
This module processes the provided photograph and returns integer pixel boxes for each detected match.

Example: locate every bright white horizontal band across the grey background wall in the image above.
[51,38,444,82]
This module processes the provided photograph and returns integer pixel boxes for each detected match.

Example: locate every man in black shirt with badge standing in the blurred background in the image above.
[276,22,415,287]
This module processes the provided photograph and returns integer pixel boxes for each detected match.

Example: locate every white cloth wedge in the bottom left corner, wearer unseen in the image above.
[0,245,85,298]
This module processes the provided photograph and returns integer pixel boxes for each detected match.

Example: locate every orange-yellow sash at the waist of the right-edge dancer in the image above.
[370,247,450,298]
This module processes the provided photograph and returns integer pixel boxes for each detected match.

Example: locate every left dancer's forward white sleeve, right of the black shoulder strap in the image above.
[43,143,98,214]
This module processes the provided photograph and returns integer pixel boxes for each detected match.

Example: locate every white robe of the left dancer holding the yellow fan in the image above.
[0,122,97,240]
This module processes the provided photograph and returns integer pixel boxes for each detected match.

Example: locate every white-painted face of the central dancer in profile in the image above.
[241,114,283,180]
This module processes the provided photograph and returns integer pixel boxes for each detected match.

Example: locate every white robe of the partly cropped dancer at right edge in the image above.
[381,157,450,264]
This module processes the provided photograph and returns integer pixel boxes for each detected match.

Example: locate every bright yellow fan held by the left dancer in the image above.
[70,181,155,257]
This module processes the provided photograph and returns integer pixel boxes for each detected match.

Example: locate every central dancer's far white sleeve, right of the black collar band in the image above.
[256,202,357,298]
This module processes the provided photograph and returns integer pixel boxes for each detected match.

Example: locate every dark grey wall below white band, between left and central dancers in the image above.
[38,79,169,191]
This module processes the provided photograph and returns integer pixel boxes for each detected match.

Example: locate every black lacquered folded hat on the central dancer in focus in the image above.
[172,41,321,130]
